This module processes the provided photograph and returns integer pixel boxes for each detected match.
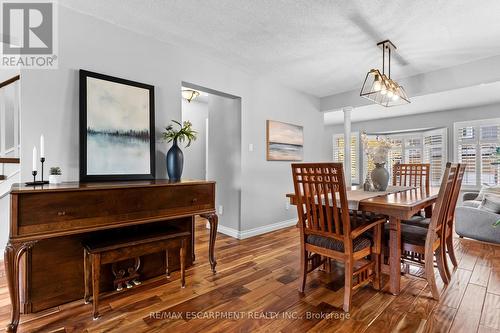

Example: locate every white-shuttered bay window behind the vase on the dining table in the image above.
[364,128,448,186]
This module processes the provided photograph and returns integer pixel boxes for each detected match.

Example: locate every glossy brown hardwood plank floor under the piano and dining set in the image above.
[0,220,500,333]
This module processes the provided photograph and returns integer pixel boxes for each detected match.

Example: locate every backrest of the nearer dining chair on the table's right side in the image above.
[429,162,459,235]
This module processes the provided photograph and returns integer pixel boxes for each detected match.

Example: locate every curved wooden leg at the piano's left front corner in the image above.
[4,241,36,332]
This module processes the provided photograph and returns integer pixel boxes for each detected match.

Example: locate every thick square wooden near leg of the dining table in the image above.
[389,217,401,295]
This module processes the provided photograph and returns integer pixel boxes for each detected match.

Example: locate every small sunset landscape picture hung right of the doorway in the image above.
[267,120,304,161]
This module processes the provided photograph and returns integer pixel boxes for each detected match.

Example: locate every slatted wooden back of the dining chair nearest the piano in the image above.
[292,163,351,239]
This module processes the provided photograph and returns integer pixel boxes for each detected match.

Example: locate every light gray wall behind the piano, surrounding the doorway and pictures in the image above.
[17,6,324,230]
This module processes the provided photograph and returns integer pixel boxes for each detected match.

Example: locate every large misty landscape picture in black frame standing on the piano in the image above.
[80,70,155,181]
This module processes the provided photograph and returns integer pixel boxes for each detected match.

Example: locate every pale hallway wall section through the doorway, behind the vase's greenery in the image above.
[182,99,208,179]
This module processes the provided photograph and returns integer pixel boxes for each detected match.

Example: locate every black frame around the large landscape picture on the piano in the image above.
[79,69,156,182]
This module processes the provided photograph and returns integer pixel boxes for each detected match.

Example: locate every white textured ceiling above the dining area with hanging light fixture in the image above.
[60,0,500,97]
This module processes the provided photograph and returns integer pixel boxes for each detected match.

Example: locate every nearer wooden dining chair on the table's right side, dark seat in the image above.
[385,163,459,300]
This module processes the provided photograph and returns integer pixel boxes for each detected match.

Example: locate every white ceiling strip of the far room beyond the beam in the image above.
[324,82,500,125]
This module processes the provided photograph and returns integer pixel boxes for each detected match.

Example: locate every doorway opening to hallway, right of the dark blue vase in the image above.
[181,82,241,232]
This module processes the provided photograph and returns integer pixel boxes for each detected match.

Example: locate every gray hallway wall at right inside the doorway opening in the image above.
[207,95,241,230]
